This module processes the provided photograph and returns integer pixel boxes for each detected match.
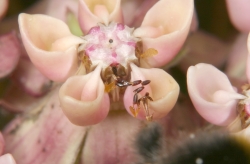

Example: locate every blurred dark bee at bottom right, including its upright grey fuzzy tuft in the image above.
[135,123,250,164]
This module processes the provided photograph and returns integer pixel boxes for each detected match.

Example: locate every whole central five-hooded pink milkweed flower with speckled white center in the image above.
[19,0,193,126]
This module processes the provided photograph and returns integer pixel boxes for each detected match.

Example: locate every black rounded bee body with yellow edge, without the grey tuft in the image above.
[165,132,250,164]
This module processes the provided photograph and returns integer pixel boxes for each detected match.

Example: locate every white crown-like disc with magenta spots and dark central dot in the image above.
[83,22,139,68]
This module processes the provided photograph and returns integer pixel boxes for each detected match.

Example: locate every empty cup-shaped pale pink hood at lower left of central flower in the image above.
[59,66,110,126]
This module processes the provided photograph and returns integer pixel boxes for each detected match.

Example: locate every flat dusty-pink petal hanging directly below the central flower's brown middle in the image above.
[81,111,141,164]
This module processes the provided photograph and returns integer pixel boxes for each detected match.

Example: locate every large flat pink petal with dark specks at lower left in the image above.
[3,89,86,164]
